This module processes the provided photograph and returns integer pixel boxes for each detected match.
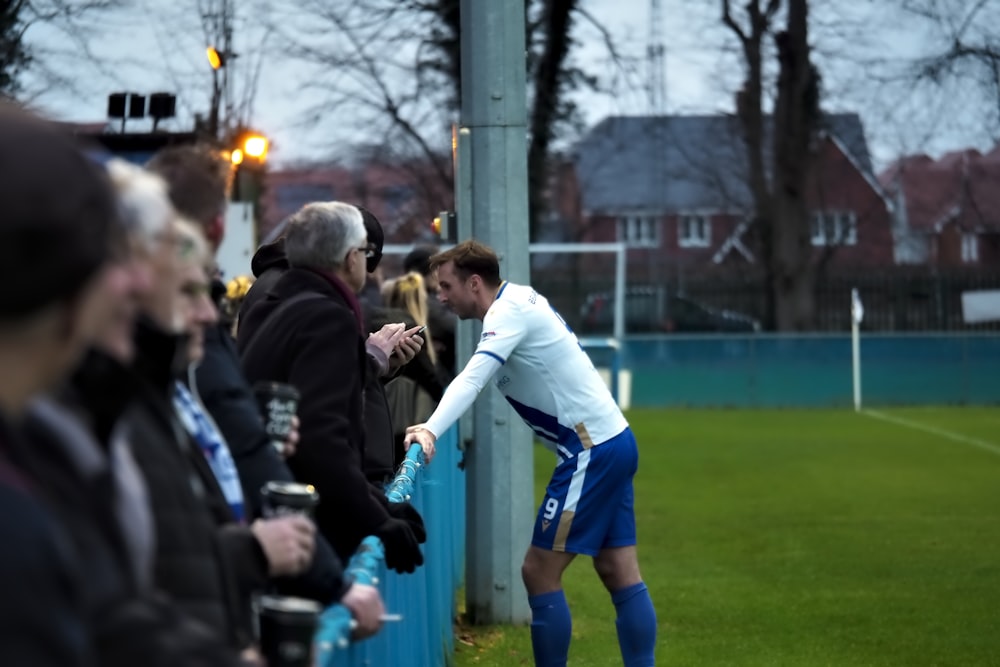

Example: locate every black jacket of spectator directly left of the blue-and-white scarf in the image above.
[125,321,258,648]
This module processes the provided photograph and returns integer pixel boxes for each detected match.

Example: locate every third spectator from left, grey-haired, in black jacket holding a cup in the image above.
[86,164,310,650]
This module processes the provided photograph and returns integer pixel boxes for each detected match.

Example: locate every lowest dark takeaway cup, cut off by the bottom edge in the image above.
[257,595,322,667]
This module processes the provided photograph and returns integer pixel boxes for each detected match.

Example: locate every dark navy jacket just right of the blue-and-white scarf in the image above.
[194,318,348,605]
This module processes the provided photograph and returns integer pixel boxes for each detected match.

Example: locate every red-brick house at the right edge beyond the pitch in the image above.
[879,145,1000,268]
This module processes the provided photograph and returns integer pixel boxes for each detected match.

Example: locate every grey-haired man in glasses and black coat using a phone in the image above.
[237,202,426,572]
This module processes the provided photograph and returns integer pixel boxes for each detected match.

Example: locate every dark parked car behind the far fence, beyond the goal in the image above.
[580,287,760,333]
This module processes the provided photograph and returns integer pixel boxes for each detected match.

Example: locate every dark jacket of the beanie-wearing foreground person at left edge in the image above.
[0,416,95,667]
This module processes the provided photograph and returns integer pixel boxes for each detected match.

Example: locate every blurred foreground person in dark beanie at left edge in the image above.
[0,102,121,667]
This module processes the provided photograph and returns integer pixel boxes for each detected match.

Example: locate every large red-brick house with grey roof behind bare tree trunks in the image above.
[550,114,893,281]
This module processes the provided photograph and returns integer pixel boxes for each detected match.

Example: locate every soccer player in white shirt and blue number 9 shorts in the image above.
[406,241,656,667]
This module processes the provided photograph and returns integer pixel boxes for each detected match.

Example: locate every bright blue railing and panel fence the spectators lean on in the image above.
[316,429,465,667]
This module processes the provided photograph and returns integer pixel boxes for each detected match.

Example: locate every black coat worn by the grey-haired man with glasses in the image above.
[237,268,389,558]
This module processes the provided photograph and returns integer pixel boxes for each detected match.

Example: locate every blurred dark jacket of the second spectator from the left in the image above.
[25,354,237,667]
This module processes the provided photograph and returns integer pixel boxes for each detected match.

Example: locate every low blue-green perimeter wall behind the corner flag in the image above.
[587,332,1000,408]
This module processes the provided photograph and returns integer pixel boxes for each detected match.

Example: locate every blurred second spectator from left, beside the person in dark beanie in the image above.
[19,155,237,667]
